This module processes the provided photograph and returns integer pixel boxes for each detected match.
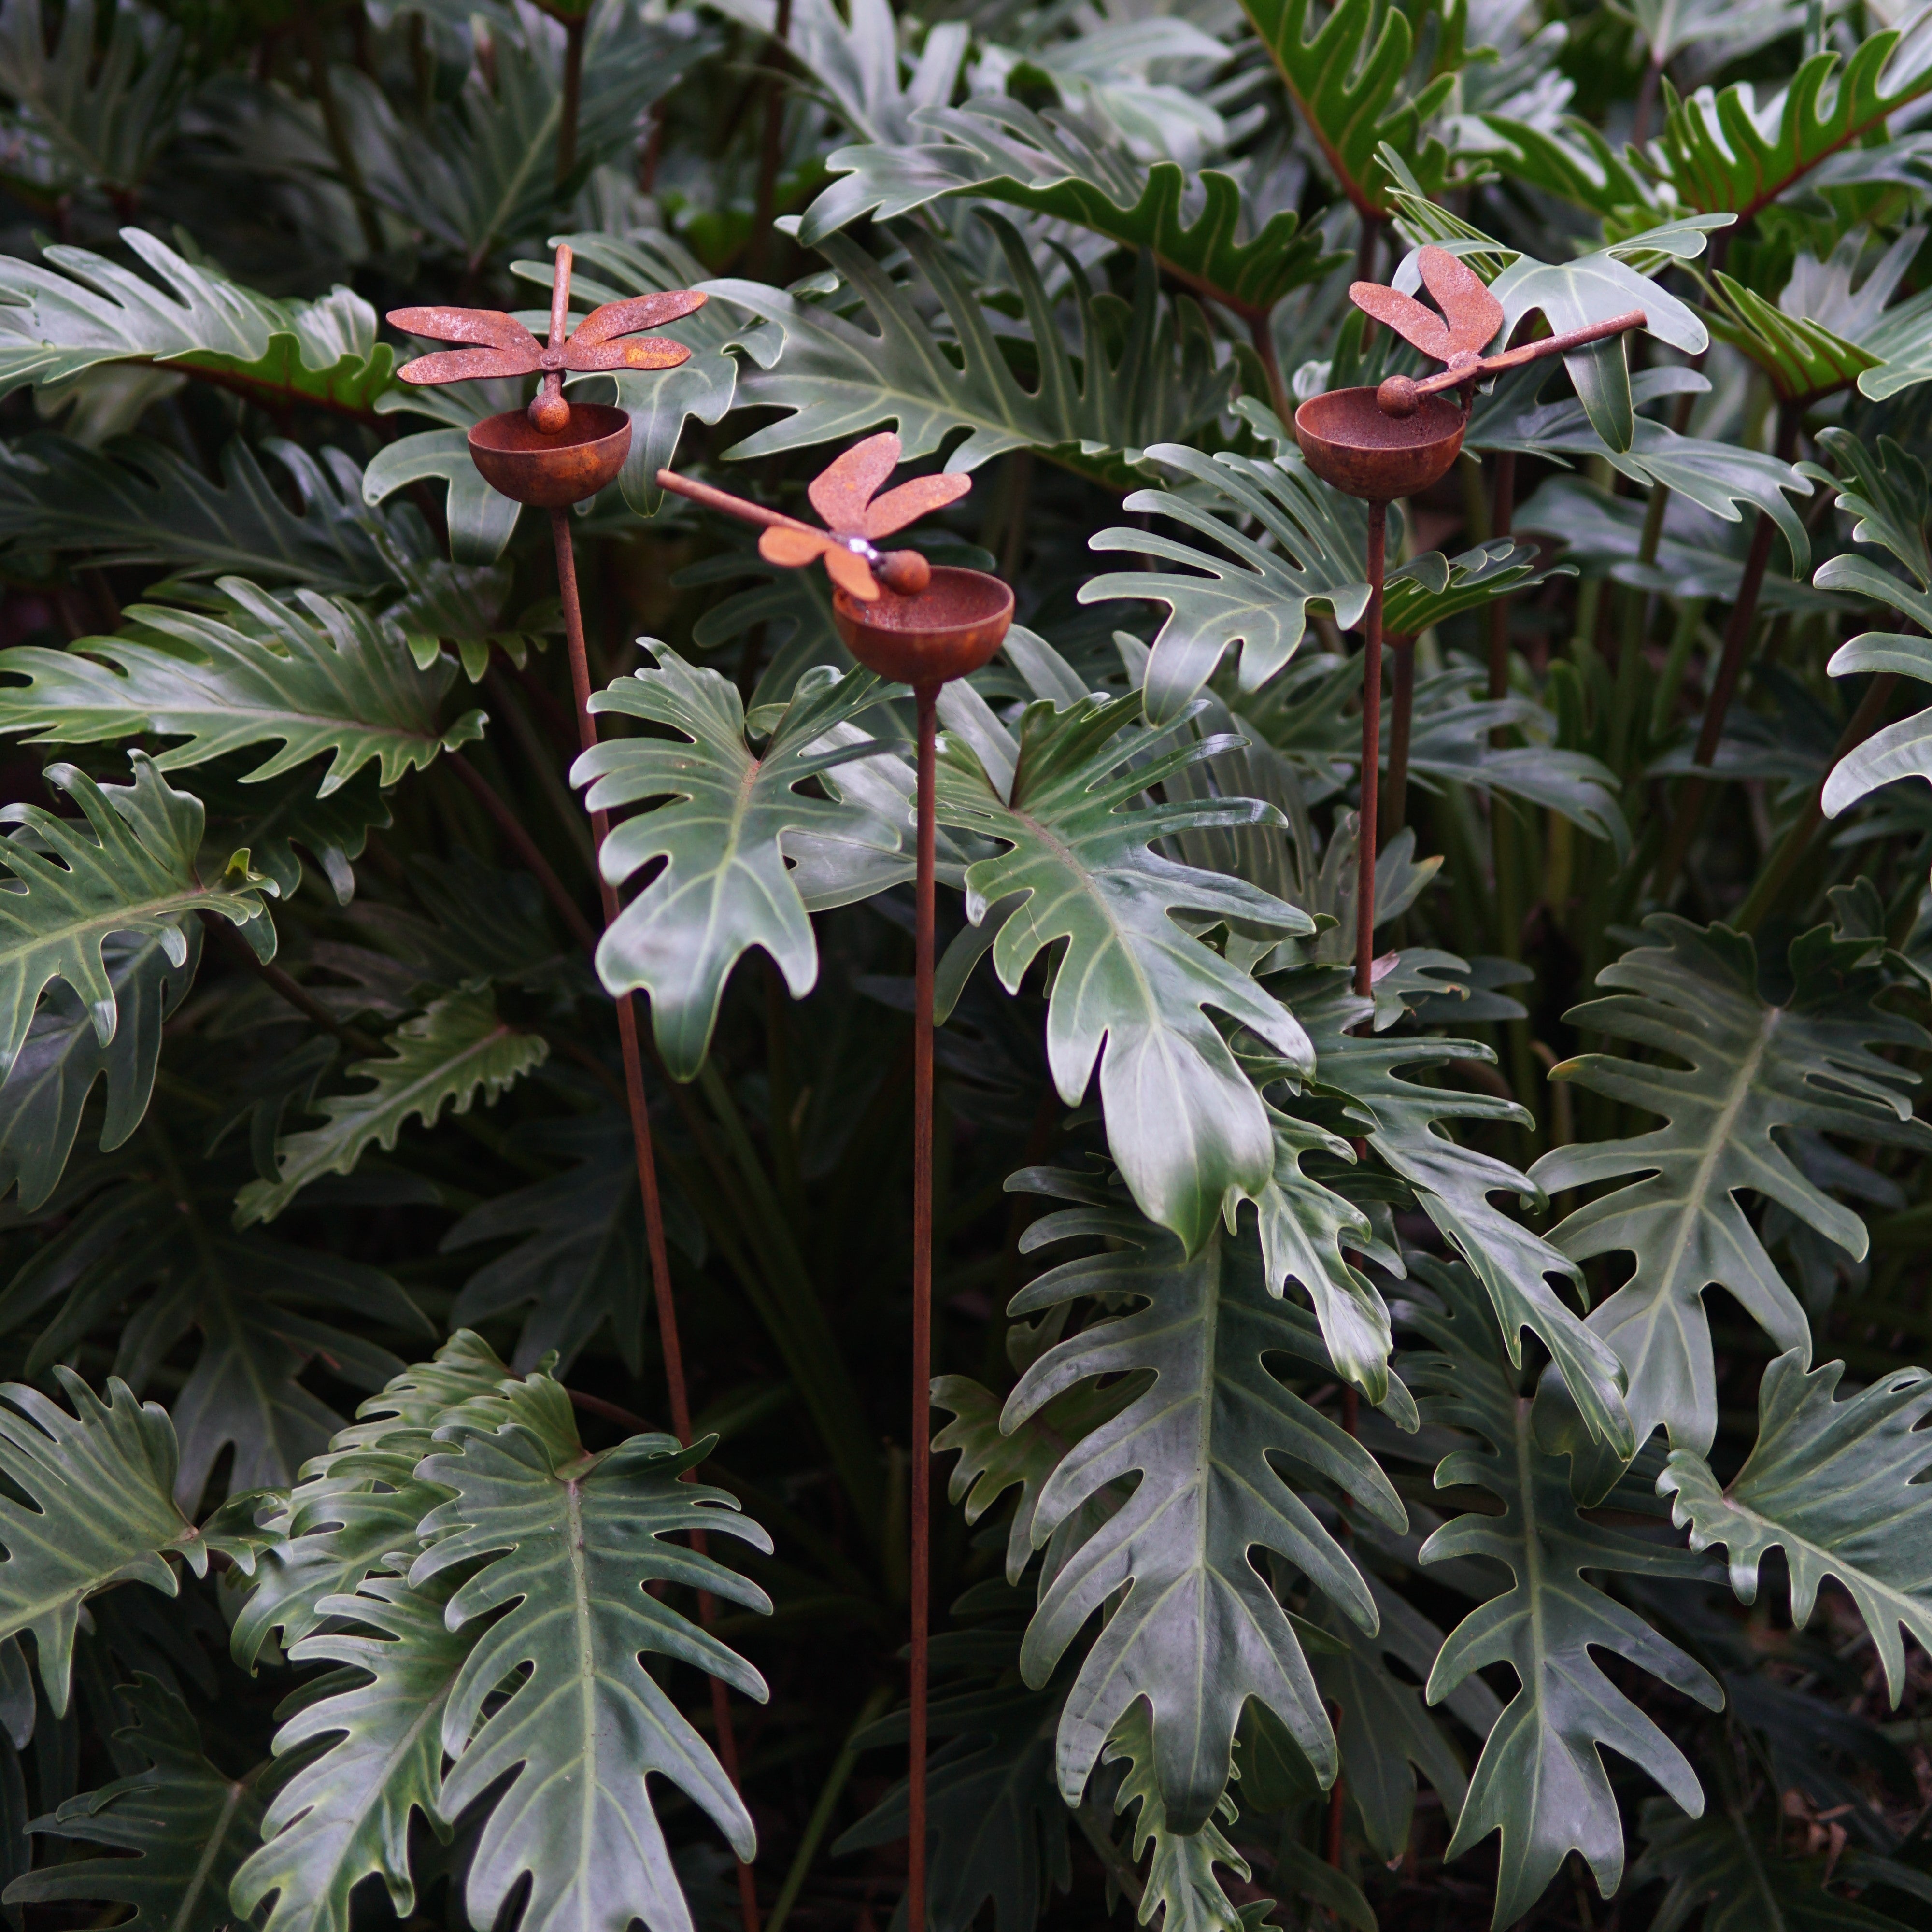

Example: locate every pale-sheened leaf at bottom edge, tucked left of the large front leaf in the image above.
[230,1577,477,1932]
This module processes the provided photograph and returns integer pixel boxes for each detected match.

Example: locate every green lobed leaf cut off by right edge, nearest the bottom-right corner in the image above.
[1658,1349,1932,1704]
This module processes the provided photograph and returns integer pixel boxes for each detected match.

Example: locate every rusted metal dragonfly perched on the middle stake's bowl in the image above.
[657,431,972,595]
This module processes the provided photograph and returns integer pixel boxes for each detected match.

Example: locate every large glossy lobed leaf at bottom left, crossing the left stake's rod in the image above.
[410,1378,771,1932]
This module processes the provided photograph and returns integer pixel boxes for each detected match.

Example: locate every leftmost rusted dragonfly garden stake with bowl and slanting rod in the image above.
[388,247,759,1932]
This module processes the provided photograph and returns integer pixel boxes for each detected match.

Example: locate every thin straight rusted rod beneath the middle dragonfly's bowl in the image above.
[906,684,939,1932]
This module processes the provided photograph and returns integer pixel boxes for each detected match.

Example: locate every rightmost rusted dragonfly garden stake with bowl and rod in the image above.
[1294,247,1644,999]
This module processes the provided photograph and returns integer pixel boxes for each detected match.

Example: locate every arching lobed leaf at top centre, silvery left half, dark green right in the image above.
[798,95,1347,321]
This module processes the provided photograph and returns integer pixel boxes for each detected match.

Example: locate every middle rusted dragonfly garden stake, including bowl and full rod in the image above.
[657,435,1012,1932]
